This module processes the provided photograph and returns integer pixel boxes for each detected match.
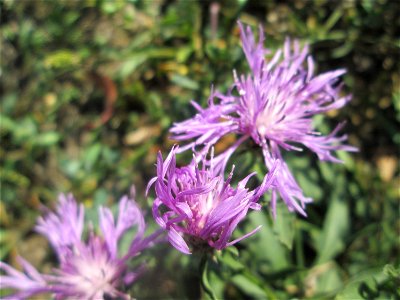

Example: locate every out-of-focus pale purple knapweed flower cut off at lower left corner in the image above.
[0,191,157,300]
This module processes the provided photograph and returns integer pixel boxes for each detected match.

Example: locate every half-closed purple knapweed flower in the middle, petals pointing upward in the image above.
[148,148,278,254]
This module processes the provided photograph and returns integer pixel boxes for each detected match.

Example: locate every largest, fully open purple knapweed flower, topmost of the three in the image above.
[171,23,356,215]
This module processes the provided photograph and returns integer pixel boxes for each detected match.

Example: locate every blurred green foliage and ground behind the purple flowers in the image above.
[0,0,400,299]
